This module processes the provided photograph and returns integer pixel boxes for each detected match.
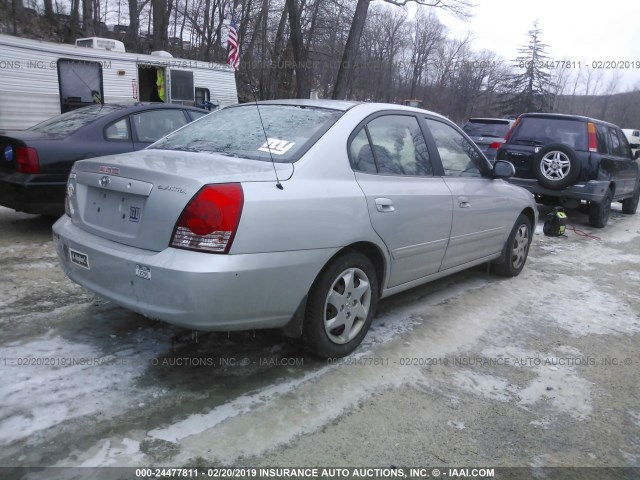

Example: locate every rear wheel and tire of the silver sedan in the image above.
[303,251,379,358]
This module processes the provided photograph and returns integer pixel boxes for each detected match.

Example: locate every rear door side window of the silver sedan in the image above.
[349,115,433,176]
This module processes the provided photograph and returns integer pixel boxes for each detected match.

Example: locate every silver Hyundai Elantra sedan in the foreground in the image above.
[53,100,538,357]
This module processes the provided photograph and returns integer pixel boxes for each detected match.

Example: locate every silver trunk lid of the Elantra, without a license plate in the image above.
[68,150,293,251]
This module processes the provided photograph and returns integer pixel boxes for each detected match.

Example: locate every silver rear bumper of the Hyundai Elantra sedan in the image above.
[53,215,335,331]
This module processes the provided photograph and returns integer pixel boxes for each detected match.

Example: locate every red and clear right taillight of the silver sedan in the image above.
[171,183,244,253]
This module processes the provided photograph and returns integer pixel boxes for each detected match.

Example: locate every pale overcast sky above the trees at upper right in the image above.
[438,0,640,91]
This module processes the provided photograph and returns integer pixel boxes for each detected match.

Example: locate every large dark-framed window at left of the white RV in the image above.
[58,58,104,113]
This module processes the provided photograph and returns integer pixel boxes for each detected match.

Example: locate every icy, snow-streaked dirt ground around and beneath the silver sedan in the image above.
[0,205,640,478]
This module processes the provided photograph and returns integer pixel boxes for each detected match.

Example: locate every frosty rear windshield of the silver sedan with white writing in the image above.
[149,104,343,163]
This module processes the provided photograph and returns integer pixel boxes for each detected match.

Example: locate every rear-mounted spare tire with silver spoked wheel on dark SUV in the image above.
[533,143,580,190]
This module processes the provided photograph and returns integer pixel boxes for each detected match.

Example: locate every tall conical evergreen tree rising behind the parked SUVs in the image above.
[501,21,552,115]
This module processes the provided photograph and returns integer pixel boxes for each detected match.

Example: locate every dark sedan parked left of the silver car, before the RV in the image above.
[0,103,209,216]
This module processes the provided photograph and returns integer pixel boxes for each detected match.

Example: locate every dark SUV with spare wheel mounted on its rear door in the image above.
[496,113,640,228]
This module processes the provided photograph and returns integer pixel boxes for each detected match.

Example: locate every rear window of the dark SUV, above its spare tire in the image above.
[509,117,587,150]
